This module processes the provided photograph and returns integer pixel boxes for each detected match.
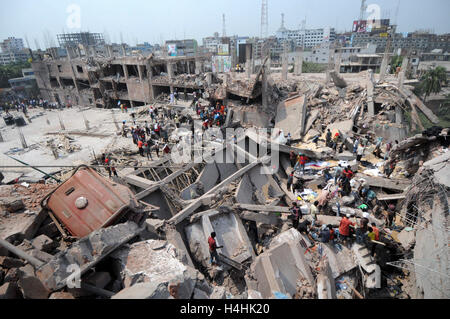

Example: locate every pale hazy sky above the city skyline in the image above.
[0,0,450,49]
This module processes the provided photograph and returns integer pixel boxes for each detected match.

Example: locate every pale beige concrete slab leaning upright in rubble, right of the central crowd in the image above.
[275,95,307,140]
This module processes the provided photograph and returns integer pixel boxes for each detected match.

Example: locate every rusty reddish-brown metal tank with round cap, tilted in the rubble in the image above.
[41,166,140,238]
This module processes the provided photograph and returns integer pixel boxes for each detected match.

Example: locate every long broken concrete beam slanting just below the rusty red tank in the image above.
[36,222,142,290]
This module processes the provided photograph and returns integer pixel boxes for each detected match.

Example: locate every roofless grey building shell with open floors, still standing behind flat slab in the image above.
[32,47,211,108]
